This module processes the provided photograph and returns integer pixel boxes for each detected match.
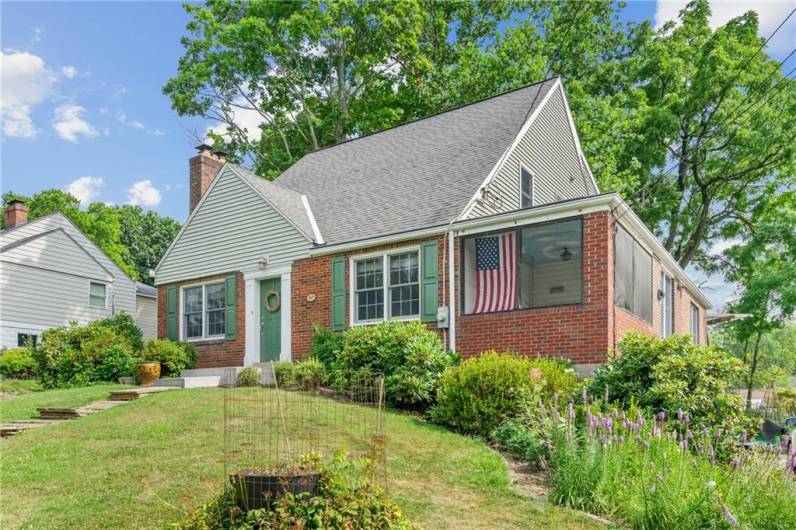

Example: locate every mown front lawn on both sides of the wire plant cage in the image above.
[0,389,598,529]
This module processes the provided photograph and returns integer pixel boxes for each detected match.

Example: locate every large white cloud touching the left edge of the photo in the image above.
[0,51,56,138]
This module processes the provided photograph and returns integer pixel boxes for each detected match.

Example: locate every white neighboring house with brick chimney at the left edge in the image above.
[0,201,152,349]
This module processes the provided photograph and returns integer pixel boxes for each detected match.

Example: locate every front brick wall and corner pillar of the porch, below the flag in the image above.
[456,212,612,364]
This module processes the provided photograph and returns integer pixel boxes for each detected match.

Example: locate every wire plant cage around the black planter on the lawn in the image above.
[223,368,387,510]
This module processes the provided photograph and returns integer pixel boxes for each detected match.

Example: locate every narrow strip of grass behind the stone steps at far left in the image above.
[0,380,126,423]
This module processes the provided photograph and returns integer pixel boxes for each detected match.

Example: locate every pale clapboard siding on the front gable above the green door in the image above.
[155,168,311,285]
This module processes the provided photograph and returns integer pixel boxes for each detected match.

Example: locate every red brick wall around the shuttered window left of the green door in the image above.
[158,272,246,368]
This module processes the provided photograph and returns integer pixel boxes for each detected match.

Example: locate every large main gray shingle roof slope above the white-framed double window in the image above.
[275,79,556,244]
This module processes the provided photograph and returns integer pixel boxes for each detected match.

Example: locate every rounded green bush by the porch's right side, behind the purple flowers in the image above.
[591,333,746,429]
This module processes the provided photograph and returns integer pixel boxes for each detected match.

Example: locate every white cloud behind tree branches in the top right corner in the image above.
[655,0,796,51]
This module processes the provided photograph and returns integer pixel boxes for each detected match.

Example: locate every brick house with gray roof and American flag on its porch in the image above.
[155,78,710,373]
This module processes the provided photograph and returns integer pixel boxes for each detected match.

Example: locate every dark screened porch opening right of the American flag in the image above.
[519,219,583,308]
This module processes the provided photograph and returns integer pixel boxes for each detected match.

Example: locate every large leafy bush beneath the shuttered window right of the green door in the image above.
[334,321,457,410]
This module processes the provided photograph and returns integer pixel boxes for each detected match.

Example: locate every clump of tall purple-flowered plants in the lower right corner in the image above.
[545,403,796,529]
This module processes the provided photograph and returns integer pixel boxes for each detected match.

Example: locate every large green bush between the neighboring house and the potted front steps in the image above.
[32,313,142,388]
